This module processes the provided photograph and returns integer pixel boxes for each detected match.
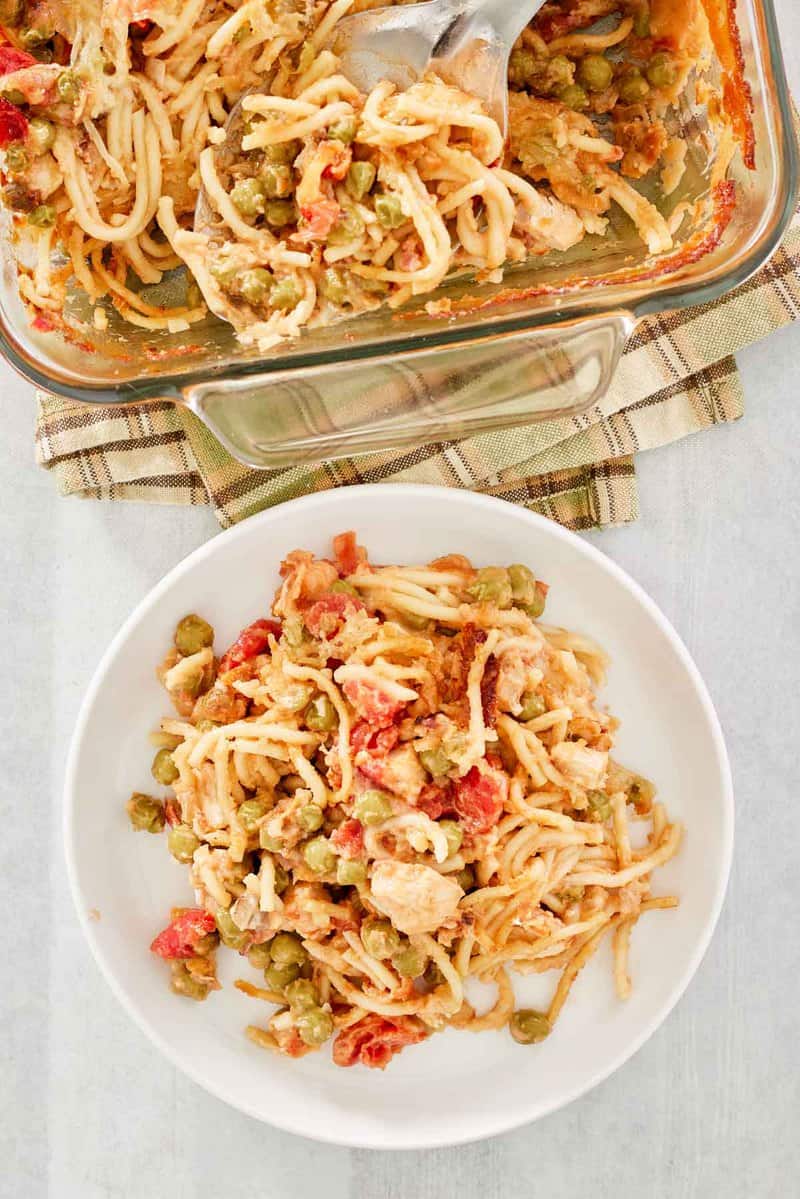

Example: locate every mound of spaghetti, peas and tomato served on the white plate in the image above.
[128,534,681,1067]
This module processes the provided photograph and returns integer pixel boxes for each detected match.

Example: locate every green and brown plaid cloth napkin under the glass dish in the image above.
[36,205,800,529]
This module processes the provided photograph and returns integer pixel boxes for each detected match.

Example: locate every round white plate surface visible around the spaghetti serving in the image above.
[65,486,733,1149]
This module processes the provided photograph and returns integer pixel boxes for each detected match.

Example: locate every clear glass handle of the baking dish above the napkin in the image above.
[182,311,636,469]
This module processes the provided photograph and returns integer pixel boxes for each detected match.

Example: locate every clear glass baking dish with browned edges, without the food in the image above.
[0,0,796,468]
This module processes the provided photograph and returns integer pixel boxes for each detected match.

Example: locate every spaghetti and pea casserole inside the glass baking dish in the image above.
[0,0,734,349]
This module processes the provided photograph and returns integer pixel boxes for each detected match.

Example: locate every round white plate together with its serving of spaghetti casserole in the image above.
[65,486,733,1147]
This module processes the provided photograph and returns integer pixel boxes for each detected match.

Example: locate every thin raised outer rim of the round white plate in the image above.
[61,483,735,1151]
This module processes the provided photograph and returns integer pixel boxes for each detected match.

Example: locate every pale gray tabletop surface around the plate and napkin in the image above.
[0,0,800,1199]
